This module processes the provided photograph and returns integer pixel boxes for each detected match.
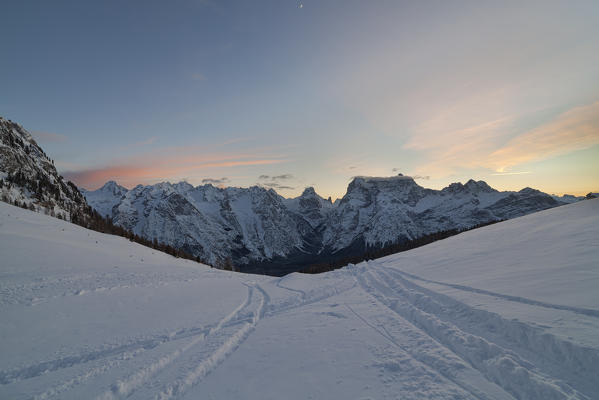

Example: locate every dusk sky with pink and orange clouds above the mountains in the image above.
[0,0,599,199]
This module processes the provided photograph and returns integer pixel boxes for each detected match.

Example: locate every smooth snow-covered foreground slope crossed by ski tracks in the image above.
[0,200,599,400]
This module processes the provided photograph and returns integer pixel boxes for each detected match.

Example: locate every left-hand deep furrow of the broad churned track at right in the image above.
[358,263,597,400]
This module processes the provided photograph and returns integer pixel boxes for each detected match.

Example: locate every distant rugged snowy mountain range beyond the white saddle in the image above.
[83,174,565,274]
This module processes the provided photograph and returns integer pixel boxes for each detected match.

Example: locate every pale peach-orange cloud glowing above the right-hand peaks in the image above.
[404,102,599,176]
